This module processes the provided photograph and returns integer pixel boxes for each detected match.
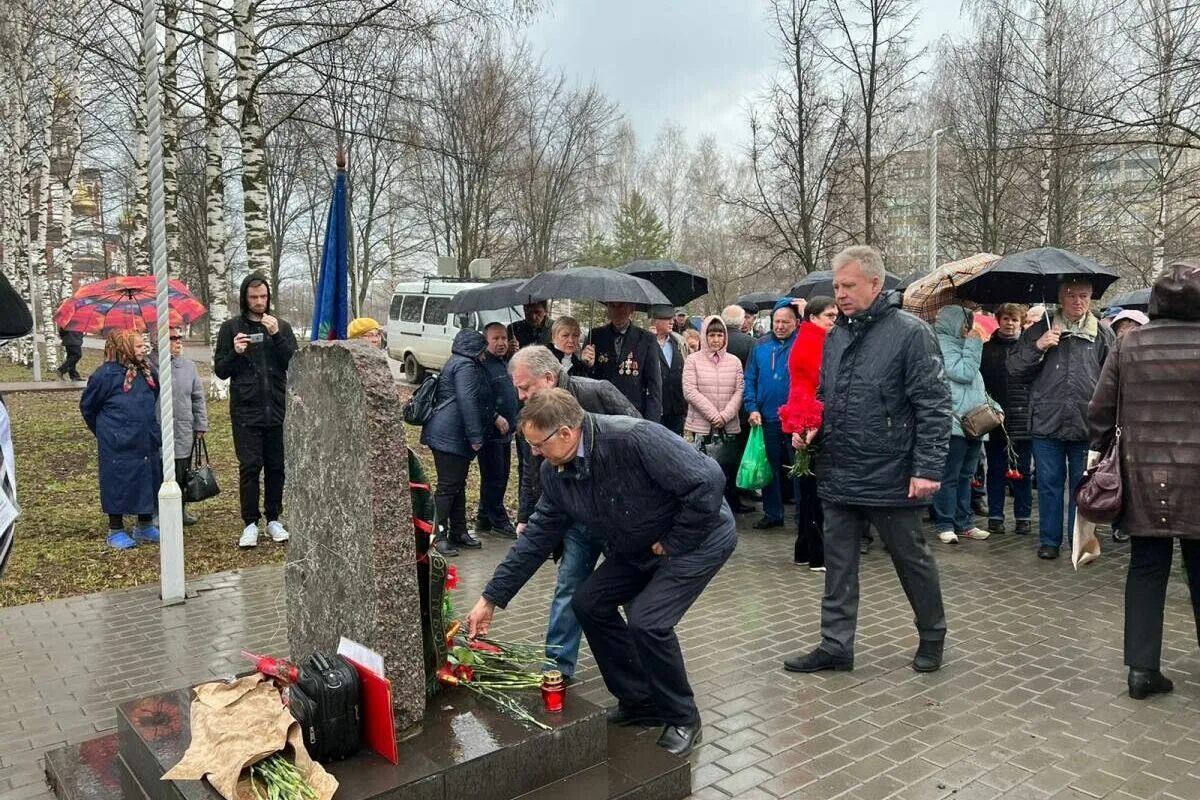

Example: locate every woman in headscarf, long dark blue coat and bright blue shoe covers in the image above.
[79,331,162,551]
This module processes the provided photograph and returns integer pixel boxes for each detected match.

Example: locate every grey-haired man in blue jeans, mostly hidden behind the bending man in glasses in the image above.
[509,347,641,678]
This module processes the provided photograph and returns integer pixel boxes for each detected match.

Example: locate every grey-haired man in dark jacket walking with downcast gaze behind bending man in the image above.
[784,246,950,672]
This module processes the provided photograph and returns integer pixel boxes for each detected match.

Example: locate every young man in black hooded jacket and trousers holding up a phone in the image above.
[212,272,296,547]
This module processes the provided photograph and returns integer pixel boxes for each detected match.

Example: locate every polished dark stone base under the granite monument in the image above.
[46,690,691,800]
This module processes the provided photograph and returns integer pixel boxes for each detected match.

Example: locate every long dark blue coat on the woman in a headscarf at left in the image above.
[79,361,162,515]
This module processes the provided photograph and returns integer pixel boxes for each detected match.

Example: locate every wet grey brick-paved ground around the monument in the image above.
[0,521,1200,800]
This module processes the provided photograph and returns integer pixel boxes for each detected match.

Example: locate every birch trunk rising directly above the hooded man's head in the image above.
[233,0,278,280]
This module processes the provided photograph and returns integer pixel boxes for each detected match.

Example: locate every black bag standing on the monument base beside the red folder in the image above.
[288,652,362,763]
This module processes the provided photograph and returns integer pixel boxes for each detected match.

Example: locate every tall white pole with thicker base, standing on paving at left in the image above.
[142,0,187,604]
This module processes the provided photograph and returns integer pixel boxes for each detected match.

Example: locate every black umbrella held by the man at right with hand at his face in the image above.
[956,247,1120,303]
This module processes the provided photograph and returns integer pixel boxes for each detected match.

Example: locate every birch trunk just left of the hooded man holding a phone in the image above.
[200,0,229,399]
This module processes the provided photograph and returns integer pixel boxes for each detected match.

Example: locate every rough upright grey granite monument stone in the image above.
[284,342,426,738]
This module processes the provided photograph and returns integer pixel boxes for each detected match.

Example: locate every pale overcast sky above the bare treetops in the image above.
[528,0,961,153]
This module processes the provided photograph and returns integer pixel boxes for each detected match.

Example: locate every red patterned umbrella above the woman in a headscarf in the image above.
[54,275,208,335]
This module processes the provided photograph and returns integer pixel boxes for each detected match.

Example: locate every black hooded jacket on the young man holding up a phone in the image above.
[212,272,296,426]
